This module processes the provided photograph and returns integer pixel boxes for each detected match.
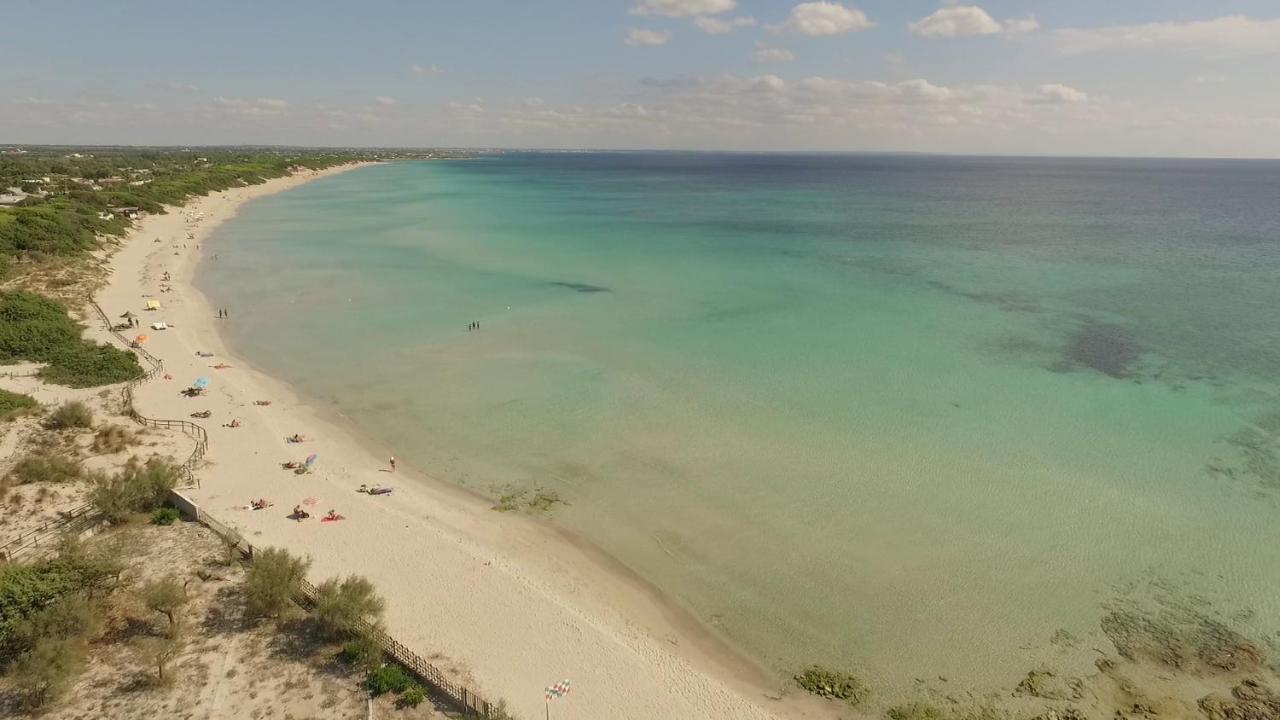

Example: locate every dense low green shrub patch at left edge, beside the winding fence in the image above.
[0,288,142,387]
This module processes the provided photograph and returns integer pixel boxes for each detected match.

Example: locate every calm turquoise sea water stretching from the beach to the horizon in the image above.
[201,154,1280,688]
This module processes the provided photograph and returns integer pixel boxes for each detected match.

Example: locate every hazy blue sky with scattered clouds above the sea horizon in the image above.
[0,0,1280,156]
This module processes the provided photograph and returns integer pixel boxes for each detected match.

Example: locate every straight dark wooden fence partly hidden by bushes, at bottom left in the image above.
[172,492,508,720]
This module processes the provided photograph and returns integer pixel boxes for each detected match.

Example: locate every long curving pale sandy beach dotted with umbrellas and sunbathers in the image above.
[90,165,824,720]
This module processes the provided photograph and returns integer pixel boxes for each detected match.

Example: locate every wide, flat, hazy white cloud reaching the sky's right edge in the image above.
[1053,15,1280,55]
